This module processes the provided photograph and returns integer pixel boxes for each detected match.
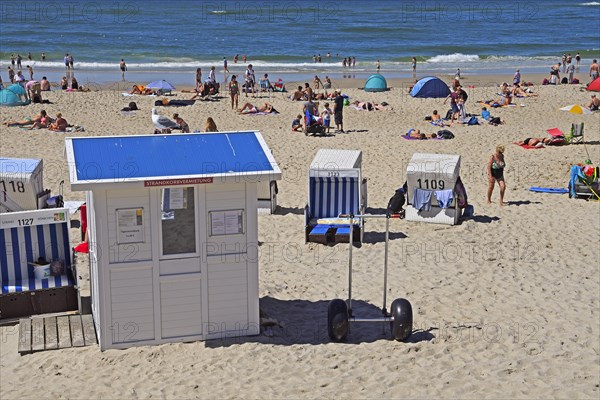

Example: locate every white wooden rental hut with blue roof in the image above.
[66,132,281,350]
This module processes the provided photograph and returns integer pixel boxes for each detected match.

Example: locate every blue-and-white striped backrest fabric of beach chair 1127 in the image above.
[0,223,74,294]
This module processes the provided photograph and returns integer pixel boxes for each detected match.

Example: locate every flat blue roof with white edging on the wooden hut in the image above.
[66,132,281,190]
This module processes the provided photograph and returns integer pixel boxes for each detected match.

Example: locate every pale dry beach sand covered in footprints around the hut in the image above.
[0,77,600,399]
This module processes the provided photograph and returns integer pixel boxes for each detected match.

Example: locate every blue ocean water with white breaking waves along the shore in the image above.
[0,0,600,81]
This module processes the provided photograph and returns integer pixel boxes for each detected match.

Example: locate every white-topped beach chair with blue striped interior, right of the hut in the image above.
[305,149,367,244]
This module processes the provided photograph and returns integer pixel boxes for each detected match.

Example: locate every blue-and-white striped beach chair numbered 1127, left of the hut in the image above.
[0,208,78,319]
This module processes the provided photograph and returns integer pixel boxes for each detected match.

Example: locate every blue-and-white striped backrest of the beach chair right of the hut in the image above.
[309,177,359,218]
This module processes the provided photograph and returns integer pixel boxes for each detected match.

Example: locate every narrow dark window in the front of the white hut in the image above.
[161,187,196,255]
